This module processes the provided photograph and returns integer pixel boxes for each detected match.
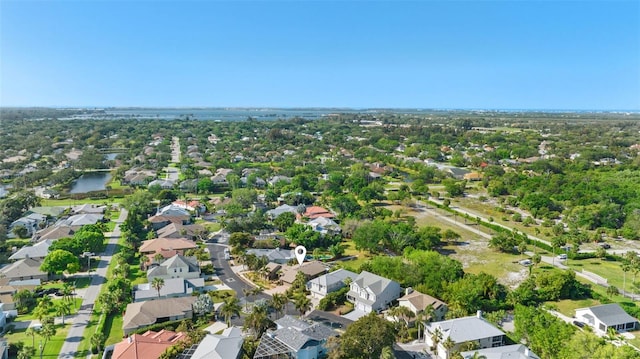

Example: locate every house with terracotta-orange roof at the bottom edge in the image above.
[111,330,187,359]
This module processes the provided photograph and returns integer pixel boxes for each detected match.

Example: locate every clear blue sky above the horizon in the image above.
[0,0,640,110]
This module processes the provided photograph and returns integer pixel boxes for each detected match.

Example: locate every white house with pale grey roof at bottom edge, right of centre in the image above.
[425,311,505,359]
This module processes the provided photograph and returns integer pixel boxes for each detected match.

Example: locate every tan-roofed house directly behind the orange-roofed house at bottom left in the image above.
[122,297,198,335]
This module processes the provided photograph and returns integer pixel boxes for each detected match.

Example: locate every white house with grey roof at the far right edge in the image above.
[576,303,638,335]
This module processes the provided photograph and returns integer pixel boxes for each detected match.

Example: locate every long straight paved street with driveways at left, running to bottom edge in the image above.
[58,208,127,358]
